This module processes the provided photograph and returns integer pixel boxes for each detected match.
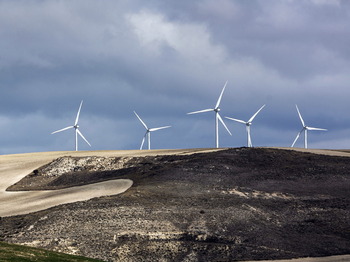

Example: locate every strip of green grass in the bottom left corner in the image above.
[0,242,101,262]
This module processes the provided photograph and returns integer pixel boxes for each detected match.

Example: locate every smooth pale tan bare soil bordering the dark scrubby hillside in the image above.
[0,148,350,262]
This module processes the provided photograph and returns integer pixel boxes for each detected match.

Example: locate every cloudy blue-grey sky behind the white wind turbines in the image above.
[0,0,350,154]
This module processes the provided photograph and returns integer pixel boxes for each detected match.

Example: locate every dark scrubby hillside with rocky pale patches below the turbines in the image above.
[0,148,350,261]
